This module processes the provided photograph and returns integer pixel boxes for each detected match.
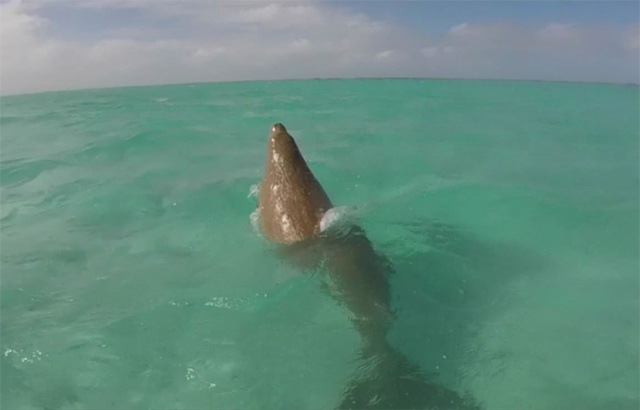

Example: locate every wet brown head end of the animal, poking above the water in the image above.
[258,123,332,244]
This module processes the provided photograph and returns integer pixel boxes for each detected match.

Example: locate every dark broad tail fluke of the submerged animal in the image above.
[338,343,480,410]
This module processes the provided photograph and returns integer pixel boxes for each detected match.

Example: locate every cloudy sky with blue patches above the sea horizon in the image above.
[0,0,640,95]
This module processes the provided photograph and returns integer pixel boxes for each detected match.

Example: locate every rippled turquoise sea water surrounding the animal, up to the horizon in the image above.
[0,80,640,410]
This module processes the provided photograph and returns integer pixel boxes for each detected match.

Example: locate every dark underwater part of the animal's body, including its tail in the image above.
[278,224,481,410]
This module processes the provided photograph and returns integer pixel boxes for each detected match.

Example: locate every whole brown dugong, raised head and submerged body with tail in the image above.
[258,123,476,409]
